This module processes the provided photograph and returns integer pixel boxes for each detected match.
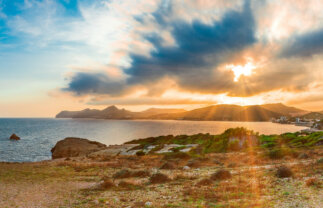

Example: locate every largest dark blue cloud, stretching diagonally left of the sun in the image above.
[66,1,256,94]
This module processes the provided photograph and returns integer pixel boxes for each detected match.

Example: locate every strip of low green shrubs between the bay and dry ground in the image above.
[128,127,323,159]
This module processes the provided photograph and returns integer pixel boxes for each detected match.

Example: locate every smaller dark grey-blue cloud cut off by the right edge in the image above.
[280,28,323,58]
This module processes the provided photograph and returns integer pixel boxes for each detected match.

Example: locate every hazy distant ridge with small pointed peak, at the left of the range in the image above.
[56,105,186,119]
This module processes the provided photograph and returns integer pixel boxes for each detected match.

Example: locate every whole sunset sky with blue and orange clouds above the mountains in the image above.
[0,0,323,117]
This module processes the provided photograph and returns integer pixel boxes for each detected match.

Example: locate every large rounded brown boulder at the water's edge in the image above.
[51,137,107,159]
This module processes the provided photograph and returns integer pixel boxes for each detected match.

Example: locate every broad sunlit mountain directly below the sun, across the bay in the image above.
[151,105,282,121]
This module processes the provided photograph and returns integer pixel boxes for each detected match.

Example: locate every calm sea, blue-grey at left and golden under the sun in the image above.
[0,118,304,162]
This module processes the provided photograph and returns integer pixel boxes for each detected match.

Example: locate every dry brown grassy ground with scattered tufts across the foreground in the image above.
[0,149,323,208]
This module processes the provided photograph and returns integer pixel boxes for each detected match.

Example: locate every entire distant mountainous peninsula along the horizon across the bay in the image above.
[56,103,323,121]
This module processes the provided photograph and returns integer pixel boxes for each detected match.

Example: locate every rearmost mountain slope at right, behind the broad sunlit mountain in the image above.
[261,103,309,117]
